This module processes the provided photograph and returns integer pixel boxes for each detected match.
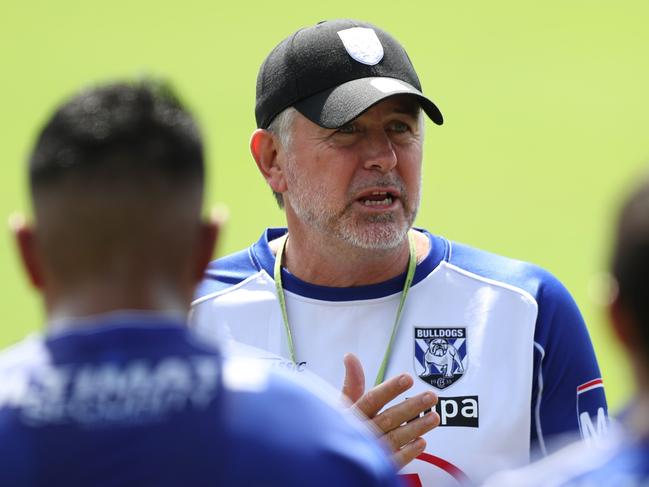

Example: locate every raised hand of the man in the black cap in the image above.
[342,353,439,468]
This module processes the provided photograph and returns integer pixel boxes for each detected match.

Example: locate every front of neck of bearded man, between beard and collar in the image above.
[270,228,430,287]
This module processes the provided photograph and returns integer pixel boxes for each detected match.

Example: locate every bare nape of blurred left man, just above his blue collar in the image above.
[45,282,191,328]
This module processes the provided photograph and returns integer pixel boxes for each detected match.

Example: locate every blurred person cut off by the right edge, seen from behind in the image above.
[480,180,649,487]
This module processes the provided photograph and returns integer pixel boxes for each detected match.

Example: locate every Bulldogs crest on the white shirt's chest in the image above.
[414,328,467,389]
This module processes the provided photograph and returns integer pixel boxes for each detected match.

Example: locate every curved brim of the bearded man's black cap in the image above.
[294,77,444,129]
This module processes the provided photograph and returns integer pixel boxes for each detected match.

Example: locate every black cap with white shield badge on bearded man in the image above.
[255,19,443,128]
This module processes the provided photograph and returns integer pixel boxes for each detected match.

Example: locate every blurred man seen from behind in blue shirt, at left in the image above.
[0,83,397,487]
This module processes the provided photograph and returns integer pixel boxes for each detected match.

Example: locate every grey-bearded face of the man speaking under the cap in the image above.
[283,96,423,249]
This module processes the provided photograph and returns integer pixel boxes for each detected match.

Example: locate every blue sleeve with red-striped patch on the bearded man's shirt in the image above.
[531,273,607,454]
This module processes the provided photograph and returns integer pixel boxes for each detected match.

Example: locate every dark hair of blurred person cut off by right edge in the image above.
[611,180,649,336]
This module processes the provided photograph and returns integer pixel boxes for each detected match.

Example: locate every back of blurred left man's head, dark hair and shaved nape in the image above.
[29,82,204,292]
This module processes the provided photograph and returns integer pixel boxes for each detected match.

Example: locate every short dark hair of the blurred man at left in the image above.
[29,81,204,192]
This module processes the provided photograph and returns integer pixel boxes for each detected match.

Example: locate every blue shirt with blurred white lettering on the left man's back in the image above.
[0,313,398,487]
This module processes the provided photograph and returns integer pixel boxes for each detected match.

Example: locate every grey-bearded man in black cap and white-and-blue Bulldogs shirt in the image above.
[193,20,606,486]
